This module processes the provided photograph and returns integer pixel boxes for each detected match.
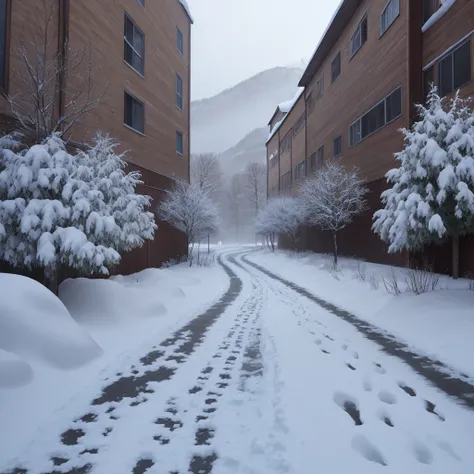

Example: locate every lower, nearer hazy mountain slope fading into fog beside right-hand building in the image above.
[219,127,268,175]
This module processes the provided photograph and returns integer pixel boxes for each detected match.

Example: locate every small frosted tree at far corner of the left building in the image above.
[158,180,219,265]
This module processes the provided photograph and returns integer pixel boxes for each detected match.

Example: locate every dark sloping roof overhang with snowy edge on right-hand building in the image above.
[298,0,362,87]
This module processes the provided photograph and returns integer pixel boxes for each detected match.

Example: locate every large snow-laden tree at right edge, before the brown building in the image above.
[373,87,474,277]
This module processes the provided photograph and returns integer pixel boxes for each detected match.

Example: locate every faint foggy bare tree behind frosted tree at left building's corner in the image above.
[191,153,222,201]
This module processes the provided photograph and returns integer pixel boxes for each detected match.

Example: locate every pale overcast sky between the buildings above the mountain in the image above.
[188,0,339,100]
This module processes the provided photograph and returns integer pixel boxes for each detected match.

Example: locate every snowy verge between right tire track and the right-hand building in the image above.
[249,251,474,380]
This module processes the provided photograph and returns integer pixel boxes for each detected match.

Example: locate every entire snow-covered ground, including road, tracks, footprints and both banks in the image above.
[0,246,474,474]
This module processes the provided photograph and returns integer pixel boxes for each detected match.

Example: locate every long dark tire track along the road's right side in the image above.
[241,251,474,409]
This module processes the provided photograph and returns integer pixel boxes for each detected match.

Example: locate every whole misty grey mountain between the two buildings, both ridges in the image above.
[191,67,303,155]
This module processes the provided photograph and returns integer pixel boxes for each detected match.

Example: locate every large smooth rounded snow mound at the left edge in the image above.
[0,273,102,369]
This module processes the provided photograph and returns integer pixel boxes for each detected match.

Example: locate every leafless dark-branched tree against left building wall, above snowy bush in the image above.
[6,0,105,143]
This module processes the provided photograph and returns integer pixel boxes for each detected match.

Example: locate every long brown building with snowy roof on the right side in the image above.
[267,0,474,272]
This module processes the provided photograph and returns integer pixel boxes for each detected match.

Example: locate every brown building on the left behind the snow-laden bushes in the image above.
[0,0,192,273]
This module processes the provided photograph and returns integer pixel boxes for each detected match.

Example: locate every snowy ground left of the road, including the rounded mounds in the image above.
[0,264,228,472]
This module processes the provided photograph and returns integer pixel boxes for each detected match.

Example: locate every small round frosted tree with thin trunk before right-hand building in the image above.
[300,160,367,266]
